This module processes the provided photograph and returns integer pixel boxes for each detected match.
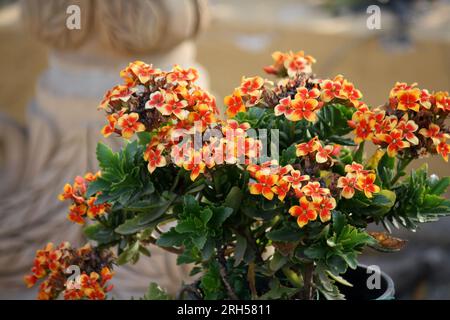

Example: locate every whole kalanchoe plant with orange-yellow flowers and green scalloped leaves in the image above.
[26,52,450,299]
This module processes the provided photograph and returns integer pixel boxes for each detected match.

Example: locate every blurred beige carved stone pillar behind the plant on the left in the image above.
[0,0,207,298]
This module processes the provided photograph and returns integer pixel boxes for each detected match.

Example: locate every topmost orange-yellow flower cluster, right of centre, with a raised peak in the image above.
[224,53,362,122]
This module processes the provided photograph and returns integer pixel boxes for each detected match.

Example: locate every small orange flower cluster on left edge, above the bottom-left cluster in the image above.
[58,172,109,224]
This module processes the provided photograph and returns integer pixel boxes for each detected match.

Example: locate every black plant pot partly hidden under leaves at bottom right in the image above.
[338,264,395,300]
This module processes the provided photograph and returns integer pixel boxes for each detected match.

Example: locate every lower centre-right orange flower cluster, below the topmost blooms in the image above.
[247,137,380,228]
